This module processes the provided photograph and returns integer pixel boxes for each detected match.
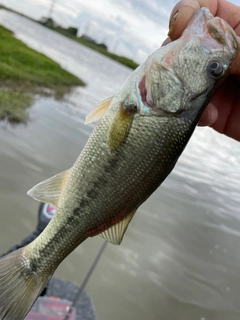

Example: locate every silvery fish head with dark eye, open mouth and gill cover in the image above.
[137,8,240,118]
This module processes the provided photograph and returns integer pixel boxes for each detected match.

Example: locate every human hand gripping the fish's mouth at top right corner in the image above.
[164,0,240,141]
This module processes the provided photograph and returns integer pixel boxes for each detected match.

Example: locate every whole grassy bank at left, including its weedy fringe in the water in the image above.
[0,26,84,122]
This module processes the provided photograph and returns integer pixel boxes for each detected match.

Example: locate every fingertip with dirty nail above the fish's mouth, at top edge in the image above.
[168,0,217,40]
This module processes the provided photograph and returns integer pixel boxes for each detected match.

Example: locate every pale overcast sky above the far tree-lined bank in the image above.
[0,0,240,62]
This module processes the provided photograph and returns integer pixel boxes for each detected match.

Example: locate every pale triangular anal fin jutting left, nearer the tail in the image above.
[27,169,71,207]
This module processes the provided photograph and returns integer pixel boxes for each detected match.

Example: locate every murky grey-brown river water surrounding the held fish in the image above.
[0,11,240,320]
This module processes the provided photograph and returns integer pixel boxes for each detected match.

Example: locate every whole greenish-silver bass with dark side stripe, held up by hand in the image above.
[0,8,240,320]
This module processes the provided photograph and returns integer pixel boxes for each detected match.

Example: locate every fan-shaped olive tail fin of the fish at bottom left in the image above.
[0,249,49,320]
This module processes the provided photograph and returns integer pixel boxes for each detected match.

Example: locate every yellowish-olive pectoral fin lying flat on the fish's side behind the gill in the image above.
[108,105,137,151]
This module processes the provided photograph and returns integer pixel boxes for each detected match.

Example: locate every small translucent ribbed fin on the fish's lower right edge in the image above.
[99,210,136,244]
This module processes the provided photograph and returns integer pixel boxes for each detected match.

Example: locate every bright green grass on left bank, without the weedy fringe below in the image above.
[0,26,84,91]
